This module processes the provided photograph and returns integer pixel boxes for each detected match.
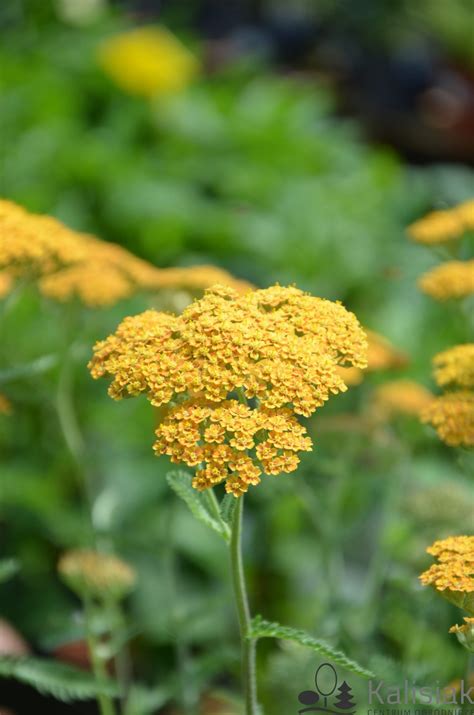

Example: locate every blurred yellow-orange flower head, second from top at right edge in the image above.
[418,260,474,300]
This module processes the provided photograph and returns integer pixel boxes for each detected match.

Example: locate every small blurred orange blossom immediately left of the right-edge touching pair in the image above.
[374,380,433,417]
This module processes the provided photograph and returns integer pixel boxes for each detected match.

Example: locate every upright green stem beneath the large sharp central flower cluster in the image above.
[230,496,259,715]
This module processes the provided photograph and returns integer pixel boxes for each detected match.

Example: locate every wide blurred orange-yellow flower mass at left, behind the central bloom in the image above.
[0,201,250,307]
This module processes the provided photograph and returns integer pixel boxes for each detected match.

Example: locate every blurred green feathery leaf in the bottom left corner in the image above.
[0,655,118,703]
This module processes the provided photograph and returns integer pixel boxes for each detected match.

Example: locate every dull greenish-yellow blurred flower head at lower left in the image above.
[58,549,136,599]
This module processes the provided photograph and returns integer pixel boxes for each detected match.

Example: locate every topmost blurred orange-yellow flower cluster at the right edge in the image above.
[408,200,474,244]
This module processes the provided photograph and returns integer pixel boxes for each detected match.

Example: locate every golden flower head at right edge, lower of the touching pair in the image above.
[420,390,474,447]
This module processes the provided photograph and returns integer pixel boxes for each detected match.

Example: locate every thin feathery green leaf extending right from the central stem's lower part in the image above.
[248,616,375,678]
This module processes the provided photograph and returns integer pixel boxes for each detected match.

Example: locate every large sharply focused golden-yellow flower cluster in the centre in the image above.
[90,285,367,496]
